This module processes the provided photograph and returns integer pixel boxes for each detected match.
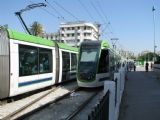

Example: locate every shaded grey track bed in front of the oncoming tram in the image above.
[18,87,101,120]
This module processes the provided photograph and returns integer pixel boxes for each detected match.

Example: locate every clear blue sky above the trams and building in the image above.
[0,0,160,53]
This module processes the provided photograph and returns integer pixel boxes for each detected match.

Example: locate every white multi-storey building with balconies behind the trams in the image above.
[59,22,100,47]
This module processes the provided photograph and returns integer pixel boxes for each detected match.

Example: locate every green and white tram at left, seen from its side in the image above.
[0,29,78,99]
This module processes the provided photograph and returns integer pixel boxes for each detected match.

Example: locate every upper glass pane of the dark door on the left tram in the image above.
[62,52,70,71]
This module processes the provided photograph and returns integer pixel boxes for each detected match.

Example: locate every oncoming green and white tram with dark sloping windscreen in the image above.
[77,41,120,87]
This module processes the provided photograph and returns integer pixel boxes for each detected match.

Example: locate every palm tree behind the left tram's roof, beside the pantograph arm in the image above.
[31,21,43,36]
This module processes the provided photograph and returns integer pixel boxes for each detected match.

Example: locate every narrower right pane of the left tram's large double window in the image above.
[39,48,52,73]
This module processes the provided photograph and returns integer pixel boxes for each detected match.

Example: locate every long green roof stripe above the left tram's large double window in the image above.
[8,30,55,47]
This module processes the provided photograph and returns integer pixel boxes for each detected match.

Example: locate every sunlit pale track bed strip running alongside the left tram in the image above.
[0,81,79,120]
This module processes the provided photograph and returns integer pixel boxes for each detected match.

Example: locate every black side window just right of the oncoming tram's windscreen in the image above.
[98,50,109,73]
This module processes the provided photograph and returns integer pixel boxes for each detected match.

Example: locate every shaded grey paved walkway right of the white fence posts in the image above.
[119,67,160,120]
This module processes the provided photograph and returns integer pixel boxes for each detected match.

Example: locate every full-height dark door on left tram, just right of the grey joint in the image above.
[62,51,70,81]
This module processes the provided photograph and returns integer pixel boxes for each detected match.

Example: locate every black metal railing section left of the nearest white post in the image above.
[88,90,109,120]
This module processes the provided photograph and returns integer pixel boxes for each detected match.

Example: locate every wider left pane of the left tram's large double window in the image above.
[19,45,38,76]
